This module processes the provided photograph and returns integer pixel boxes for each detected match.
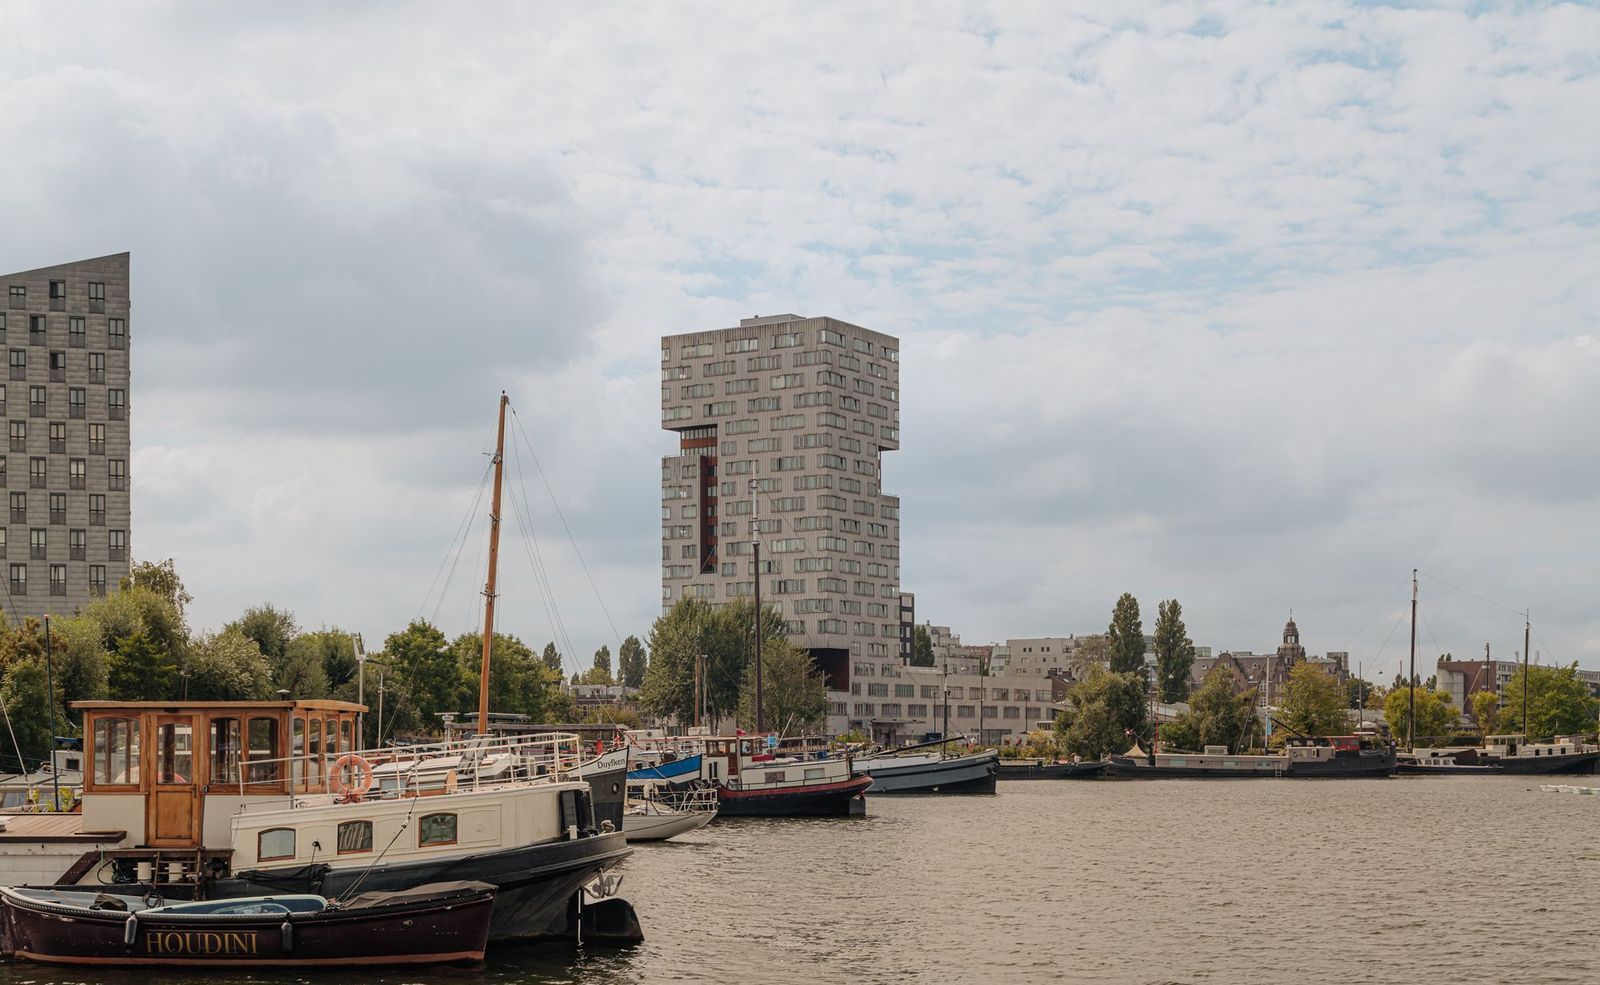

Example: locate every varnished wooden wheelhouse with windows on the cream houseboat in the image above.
[72,700,366,849]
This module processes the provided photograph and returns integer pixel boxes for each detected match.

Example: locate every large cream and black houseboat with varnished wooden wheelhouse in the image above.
[0,700,637,940]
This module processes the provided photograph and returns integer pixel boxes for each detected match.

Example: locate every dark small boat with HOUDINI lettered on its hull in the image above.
[0,883,494,967]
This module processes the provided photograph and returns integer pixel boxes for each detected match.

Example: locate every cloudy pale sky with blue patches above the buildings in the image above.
[0,0,1600,676]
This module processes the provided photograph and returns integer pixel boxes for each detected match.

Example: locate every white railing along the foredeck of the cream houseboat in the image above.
[229,732,584,806]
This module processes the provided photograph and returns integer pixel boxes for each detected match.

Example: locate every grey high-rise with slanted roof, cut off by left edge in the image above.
[0,253,130,622]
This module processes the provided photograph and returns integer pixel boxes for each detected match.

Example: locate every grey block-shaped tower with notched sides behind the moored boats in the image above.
[661,315,901,700]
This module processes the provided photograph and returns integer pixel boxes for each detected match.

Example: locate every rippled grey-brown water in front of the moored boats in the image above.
[0,777,1600,985]
